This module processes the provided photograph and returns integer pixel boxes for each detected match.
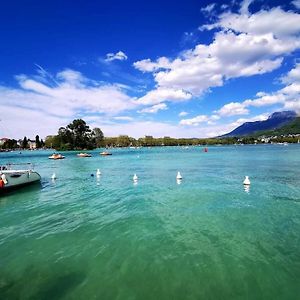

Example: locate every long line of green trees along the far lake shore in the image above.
[0,119,300,150]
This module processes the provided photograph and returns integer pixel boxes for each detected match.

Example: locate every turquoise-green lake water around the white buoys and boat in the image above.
[0,145,300,299]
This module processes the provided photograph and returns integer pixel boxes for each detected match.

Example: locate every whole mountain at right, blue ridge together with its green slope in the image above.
[222,111,300,137]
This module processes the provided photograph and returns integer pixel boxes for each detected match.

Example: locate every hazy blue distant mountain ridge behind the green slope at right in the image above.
[222,111,297,137]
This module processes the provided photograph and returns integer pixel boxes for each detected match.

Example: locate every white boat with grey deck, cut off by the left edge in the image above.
[0,164,41,192]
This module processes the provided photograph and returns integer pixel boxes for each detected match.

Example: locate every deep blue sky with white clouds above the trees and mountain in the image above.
[0,0,300,138]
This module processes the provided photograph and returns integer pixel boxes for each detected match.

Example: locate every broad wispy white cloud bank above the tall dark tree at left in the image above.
[0,69,138,134]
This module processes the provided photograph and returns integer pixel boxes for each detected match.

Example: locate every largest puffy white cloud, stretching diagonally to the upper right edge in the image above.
[134,0,300,103]
